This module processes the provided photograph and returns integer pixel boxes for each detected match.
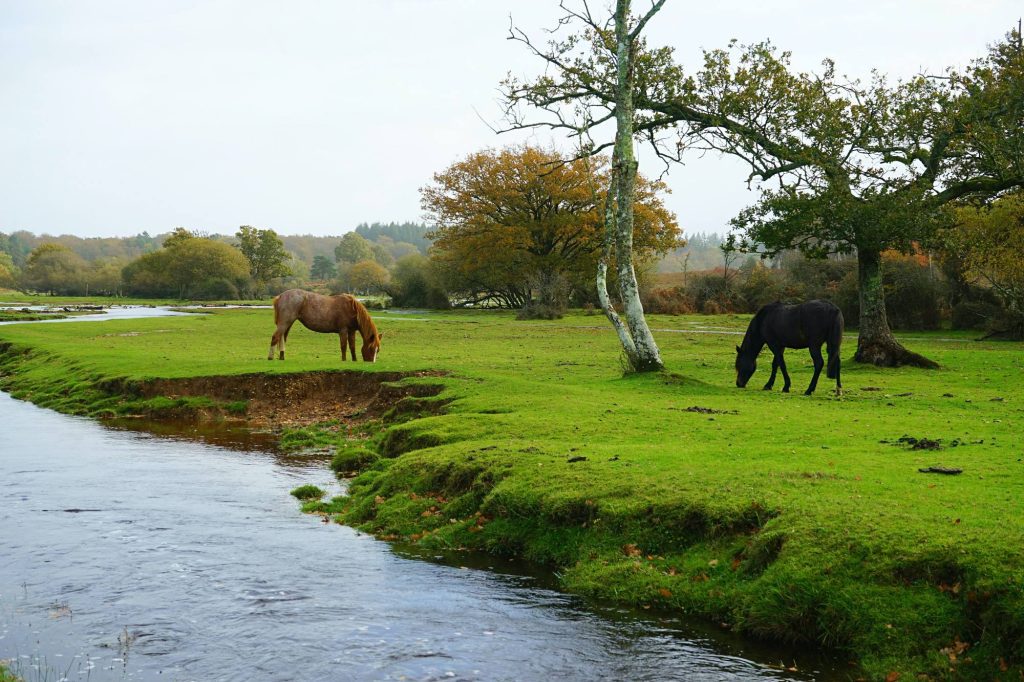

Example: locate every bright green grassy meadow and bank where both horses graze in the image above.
[0,310,1024,679]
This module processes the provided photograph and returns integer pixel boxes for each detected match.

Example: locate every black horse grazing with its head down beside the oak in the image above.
[736,301,843,395]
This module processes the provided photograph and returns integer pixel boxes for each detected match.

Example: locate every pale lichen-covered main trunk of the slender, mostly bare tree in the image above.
[611,0,664,372]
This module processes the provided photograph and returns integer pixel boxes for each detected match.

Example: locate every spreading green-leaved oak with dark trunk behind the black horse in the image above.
[506,15,1024,366]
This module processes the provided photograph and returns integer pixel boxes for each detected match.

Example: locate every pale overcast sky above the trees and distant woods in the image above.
[0,0,1024,237]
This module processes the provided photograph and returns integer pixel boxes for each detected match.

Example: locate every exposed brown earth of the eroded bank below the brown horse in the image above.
[126,371,443,427]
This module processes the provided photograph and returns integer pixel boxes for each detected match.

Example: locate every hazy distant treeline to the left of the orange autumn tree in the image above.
[0,222,430,300]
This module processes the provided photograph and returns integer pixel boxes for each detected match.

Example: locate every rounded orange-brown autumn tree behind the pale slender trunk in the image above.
[421,146,680,307]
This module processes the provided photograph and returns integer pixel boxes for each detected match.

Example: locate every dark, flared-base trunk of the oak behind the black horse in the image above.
[853,248,939,368]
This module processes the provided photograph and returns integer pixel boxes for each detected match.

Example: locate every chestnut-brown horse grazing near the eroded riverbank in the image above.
[266,289,383,363]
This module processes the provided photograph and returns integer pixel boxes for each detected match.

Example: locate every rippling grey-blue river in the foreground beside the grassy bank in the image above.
[0,309,834,682]
